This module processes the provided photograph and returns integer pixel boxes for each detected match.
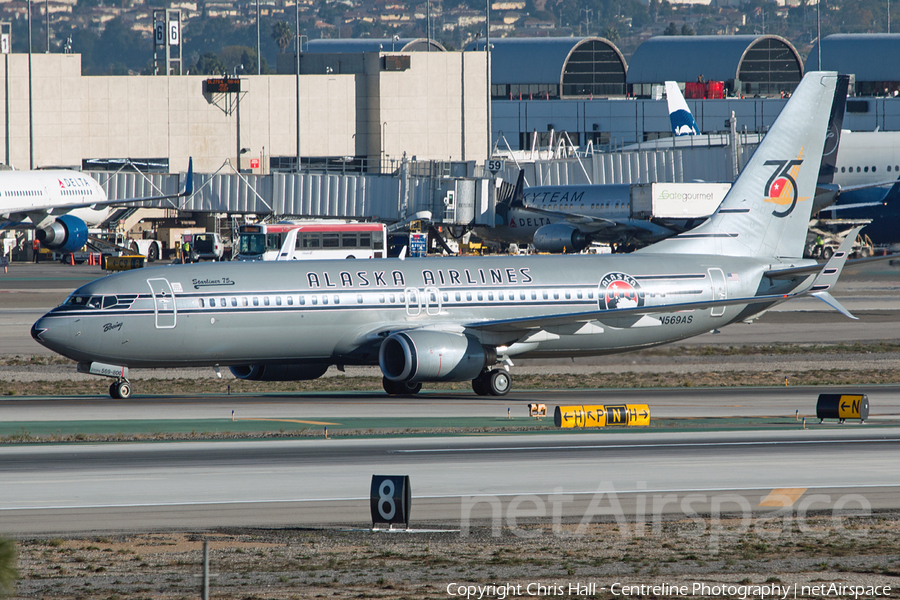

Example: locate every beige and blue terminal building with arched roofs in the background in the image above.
[0,34,900,175]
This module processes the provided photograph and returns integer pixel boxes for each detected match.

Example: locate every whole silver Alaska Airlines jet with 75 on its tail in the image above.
[31,72,872,397]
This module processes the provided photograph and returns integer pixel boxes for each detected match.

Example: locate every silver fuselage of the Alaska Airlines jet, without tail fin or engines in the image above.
[33,254,806,367]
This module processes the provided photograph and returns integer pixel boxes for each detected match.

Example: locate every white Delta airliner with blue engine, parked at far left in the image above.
[0,161,194,253]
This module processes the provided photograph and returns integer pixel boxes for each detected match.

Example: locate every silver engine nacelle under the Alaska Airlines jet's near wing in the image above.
[378,329,497,383]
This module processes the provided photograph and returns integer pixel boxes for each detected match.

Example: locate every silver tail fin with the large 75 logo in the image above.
[645,71,846,258]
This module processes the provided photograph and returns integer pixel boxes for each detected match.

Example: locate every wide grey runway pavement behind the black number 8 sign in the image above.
[0,429,900,535]
